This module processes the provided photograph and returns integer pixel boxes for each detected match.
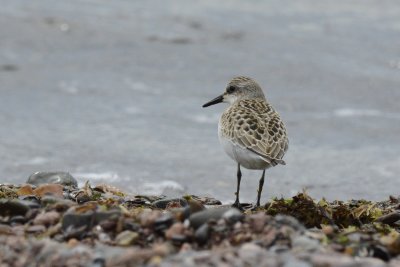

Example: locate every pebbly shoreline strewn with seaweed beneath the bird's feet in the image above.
[0,173,400,266]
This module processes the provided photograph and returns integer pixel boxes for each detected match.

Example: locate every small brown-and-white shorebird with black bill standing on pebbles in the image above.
[203,76,289,208]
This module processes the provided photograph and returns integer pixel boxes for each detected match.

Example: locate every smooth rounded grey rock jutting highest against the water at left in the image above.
[27,172,78,187]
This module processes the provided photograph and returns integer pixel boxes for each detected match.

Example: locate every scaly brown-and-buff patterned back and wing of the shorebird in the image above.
[220,100,288,165]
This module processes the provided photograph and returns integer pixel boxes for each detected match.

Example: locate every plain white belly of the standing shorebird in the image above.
[218,125,271,170]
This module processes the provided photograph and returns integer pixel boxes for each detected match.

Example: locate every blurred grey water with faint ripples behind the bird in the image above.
[0,0,400,202]
